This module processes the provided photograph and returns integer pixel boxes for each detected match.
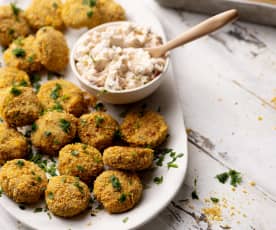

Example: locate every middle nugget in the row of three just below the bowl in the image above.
[78,112,119,150]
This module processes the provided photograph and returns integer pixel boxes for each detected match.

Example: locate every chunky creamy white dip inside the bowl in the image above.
[74,23,166,91]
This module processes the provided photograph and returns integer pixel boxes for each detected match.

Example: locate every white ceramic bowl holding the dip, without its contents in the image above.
[70,21,169,104]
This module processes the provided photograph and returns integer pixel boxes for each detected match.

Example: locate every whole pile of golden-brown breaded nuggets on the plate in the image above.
[0,0,168,217]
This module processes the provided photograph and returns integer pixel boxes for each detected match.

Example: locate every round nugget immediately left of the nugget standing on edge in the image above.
[58,143,103,183]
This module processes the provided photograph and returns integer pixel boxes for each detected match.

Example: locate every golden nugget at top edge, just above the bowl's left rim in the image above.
[62,0,102,28]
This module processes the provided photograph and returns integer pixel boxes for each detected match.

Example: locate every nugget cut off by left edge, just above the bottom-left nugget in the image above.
[0,123,28,164]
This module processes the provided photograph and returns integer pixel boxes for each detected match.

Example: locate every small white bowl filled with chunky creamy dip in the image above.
[70,21,168,104]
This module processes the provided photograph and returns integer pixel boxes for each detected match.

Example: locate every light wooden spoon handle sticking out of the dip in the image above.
[145,9,238,57]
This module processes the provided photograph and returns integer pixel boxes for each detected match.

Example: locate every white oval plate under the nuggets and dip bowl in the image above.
[0,0,188,230]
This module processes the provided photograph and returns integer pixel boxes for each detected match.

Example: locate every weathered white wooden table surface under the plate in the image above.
[0,0,276,230]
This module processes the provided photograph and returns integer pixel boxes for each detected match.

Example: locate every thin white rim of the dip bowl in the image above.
[70,21,170,94]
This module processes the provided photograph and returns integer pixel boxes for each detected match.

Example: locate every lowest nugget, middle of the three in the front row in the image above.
[45,176,90,217]
